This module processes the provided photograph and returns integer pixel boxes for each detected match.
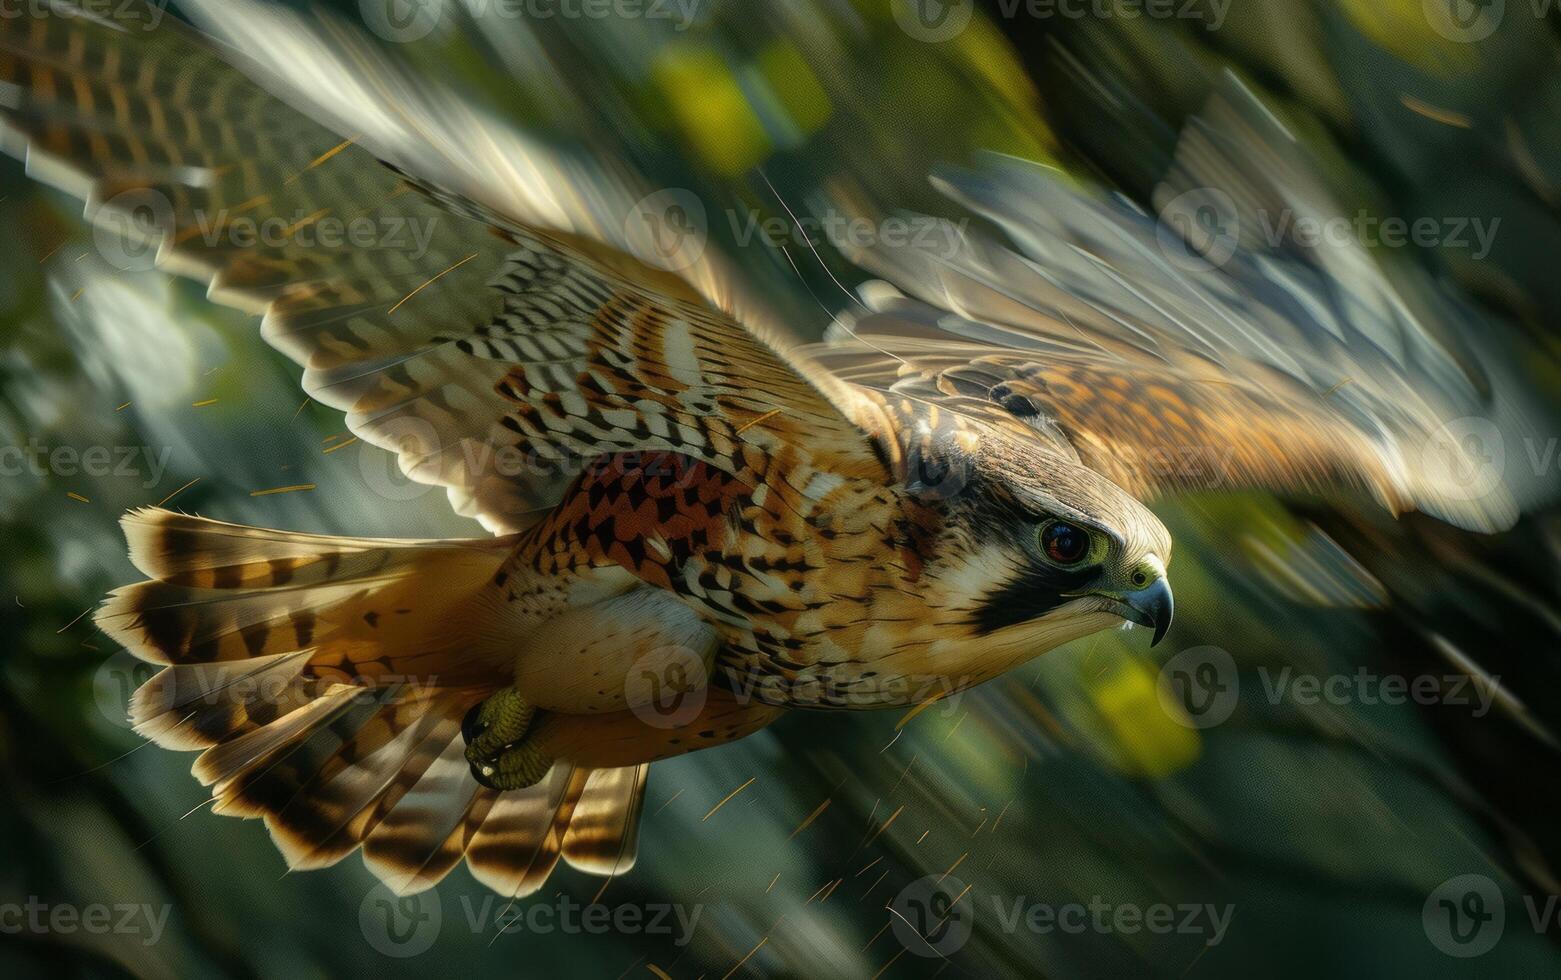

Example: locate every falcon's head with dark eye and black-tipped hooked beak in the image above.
[907,426,1172,652]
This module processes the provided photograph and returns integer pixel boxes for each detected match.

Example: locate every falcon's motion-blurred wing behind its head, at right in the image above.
[812,81,1525,529]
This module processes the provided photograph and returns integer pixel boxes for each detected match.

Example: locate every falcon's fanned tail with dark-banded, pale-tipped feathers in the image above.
[97,510,649,897]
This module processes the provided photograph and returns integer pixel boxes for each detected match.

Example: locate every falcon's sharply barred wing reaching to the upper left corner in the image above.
[0,3,880,532]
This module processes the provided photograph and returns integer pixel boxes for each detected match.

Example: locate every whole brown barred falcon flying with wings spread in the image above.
[0,0,1517,896]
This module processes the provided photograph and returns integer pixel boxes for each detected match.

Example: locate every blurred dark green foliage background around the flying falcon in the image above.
[0,0,1561,977]
